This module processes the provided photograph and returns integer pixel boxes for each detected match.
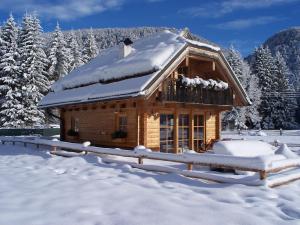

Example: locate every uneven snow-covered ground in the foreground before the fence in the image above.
[0,138,300,225]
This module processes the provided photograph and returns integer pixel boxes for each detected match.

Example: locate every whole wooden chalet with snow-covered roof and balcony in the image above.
[40,31,250,153]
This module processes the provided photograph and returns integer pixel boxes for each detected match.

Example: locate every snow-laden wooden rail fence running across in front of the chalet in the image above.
[0,137,300,187]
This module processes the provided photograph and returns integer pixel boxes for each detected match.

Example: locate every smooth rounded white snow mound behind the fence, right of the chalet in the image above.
[213,140,274,157]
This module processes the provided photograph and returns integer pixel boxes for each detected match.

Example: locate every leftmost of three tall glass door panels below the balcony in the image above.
[160,114,174,153]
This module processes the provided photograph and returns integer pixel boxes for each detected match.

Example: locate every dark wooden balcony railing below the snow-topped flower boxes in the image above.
[161,80,233,105]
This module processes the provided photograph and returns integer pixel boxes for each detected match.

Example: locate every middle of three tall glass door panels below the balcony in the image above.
[178,114,190,149]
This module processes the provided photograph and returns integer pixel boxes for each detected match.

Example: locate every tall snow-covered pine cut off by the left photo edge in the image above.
[0,15,23,127]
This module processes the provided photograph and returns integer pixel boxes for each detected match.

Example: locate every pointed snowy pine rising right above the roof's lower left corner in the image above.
[48,23,70,82]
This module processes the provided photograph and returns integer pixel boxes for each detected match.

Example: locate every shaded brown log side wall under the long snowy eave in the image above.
[63,102,138,148]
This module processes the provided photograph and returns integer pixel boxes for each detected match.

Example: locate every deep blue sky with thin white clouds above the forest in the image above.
[0,0,300,56]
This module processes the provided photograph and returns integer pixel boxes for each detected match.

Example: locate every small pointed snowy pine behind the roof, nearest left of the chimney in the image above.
[83,28,99,63]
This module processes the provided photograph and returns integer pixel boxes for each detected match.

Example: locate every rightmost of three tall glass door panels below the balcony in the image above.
[193,115,204,152]
